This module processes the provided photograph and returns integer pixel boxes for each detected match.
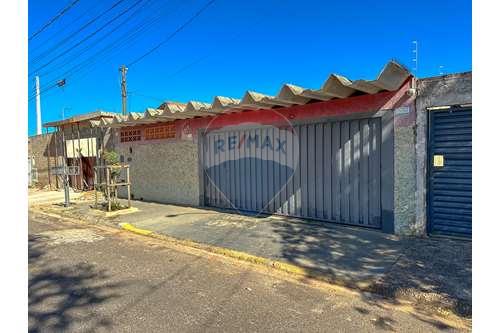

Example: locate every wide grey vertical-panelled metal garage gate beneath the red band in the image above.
[200,112,394,232]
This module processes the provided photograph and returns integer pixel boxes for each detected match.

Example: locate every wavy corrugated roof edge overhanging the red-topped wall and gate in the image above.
[92,61,410,127]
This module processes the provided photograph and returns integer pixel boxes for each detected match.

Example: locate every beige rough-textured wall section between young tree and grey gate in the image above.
[116,140,200,206]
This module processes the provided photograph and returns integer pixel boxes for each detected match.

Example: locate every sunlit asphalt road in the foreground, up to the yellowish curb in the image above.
[29,214,466,332]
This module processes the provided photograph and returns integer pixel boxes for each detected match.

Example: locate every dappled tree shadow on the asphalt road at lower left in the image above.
[28,235,122,332]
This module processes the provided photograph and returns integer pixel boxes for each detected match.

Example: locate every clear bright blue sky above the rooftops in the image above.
[28,0,472,135]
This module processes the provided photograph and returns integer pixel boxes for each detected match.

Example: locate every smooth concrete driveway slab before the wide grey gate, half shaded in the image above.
[127,205,404,286]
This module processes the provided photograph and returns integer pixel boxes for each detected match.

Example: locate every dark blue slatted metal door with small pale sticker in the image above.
[428,108,472,237]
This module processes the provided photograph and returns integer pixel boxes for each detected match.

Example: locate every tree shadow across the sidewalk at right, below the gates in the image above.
[271,222,472,318]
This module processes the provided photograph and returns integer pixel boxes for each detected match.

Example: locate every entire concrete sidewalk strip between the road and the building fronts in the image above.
[32,195,472,315]
